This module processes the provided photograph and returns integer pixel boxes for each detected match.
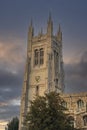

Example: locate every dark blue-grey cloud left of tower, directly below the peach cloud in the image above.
[0,69,23,101]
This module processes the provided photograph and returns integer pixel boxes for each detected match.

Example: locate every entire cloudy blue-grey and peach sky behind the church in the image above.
[0,0,87,130]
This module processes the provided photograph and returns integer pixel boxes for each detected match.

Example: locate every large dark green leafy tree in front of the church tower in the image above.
[24,92,72,130]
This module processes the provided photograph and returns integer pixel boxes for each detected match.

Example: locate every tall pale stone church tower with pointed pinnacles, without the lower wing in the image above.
[19,15,64,130]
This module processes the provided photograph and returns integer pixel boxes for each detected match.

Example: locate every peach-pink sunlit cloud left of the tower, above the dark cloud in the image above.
[0,38,26,73]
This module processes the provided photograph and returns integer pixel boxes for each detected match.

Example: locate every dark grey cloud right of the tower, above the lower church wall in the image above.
[65,51,87,93]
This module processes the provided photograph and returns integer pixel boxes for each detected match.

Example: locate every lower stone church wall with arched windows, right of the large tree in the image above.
[62,93,87,129]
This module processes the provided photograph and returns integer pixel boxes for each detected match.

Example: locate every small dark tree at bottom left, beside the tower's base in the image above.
[7,117,19,130]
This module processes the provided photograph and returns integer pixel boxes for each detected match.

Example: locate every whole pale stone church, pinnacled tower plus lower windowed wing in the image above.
[19,15,87,130]
